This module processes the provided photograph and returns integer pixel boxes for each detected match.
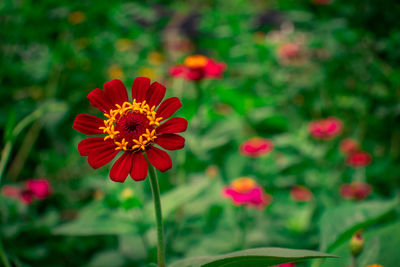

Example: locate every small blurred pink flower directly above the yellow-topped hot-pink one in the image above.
[239,137,274,158]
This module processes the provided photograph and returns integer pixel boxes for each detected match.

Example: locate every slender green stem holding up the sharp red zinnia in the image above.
[145,155,165,267]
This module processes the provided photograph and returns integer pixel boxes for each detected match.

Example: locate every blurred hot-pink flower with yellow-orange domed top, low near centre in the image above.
[222,177,272,209]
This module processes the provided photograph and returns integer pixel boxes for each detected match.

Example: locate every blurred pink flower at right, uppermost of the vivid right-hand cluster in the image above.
[308,117,343,140]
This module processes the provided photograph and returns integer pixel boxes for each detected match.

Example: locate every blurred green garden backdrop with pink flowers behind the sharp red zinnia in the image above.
[0,0,400,267]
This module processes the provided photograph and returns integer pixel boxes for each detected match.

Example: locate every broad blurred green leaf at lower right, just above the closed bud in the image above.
[320,201,395,252]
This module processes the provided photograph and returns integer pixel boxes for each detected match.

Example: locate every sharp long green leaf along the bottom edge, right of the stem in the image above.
[170,248,336,267]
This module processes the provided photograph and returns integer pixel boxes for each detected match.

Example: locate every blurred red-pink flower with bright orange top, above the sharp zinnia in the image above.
[169,55,226,81]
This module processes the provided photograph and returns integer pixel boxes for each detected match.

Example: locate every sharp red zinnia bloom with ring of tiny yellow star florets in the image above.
[73,77,187,182]
